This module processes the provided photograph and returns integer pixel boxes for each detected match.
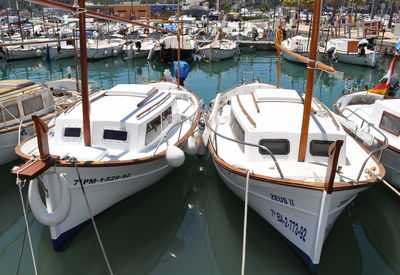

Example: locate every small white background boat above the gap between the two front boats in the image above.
[197,40,239,62]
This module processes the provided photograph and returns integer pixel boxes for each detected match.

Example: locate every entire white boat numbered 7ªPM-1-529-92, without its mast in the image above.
[14,82,200,249]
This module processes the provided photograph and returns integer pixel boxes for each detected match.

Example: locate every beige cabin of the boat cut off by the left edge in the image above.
[0,80,55,128]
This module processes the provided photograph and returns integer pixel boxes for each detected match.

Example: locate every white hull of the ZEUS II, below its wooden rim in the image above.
[214,161,366,270]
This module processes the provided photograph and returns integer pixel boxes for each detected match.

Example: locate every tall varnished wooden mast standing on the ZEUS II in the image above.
[297,0,321,162]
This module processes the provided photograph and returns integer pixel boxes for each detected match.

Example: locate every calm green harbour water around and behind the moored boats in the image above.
[0,52,400,275]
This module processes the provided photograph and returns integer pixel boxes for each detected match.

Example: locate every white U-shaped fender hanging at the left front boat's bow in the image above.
[28,174,71,226]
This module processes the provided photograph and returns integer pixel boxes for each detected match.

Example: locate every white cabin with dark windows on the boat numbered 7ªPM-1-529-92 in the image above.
[54,84,190,160]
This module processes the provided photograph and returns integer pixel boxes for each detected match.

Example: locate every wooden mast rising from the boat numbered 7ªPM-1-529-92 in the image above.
[79,0,91,146]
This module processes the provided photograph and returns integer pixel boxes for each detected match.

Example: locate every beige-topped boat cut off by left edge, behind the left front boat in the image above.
[0,79,76,165]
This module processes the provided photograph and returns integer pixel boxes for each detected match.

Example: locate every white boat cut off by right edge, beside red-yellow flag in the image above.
[334,91,400,187]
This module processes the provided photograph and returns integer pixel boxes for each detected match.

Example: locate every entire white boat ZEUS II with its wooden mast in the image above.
[203,3,385,272]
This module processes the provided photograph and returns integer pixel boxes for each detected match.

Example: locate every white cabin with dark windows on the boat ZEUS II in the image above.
[222,88,346,164]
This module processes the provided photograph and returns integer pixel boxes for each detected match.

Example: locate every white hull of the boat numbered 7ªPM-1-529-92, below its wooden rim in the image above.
[40,158,173,250]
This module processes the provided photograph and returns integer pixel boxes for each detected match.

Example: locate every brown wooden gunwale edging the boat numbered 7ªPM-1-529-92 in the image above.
[15,88,201,167]
